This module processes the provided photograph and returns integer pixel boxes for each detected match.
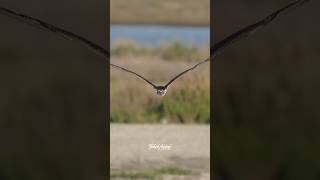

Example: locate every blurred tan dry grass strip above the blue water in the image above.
[110,0,210,25]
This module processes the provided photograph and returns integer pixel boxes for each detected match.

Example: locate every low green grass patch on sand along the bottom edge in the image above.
[111,166,200,180]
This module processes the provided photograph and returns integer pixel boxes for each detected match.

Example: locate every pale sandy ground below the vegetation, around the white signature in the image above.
[110,124,210,179]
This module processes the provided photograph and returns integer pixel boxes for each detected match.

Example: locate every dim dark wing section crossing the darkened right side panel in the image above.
[210,0,310,59]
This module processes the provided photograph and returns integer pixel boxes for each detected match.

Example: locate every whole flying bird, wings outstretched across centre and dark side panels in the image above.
[0,0,310,96]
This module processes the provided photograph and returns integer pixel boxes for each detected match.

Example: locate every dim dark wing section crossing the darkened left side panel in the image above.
[0,6,110,59]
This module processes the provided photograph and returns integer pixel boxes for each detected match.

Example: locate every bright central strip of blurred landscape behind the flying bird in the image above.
[110,0,210,179]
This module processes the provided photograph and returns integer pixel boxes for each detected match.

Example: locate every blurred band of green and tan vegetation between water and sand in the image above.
[110,42,210,123]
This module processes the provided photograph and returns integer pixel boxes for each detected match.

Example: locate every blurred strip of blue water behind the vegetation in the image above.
[110,25,210,48]
